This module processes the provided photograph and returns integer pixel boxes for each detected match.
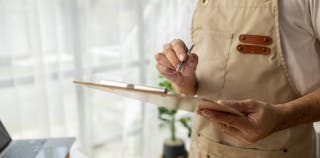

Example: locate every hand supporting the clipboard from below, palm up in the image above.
[197,100,282,145]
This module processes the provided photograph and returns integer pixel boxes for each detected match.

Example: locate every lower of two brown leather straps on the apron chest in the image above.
[237,44,271,55]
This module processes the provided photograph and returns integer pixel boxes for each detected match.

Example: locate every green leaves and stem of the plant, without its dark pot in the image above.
[158,75,191,141]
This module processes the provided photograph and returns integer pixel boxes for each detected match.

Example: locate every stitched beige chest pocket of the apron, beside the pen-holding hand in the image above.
[193,30,233,99]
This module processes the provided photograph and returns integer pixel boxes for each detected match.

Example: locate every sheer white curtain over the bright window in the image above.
[0,0,196,158]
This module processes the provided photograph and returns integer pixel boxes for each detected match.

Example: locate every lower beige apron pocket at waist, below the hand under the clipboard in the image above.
[198,136,288,158]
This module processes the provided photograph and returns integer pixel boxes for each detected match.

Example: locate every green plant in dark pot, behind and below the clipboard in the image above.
[158,75,191,158]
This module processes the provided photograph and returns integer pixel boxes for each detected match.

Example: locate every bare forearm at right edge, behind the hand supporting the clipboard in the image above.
[275,88,320,130]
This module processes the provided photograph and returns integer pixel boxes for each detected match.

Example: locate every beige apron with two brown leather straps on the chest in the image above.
[190,0,316,158]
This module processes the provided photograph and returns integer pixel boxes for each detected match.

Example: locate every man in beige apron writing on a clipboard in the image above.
[155,0,320,158]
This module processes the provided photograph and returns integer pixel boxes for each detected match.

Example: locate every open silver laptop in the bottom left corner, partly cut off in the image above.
[0,121,75,158]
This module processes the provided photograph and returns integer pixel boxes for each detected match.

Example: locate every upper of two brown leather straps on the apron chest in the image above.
[239,34,272,45]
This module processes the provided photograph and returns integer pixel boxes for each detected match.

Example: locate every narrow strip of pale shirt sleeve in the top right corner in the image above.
[309,0,320,41]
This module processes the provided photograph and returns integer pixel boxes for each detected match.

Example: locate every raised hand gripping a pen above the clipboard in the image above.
[155,39,198,95]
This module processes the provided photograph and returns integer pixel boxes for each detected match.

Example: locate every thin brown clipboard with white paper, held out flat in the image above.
[73,81,243,116]
